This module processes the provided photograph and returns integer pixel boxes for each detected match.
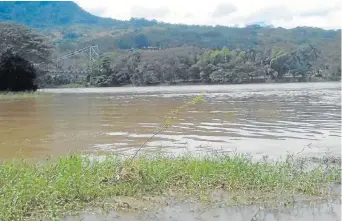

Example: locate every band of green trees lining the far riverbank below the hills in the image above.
[42,45,341,87]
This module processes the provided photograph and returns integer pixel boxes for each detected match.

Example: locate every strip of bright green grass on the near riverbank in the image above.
[0,155,341,221]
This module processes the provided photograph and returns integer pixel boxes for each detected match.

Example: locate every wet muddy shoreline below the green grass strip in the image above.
[56,196,341,221]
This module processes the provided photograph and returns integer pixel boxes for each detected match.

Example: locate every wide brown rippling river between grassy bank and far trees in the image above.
[0,83,341,159]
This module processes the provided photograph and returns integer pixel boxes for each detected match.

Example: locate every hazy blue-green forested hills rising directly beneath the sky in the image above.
[0,1,341,52]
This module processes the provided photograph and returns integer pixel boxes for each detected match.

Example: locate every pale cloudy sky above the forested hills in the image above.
[76,0,342,29]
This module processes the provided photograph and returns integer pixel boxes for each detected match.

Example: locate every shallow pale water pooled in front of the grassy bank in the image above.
[62,199,341,221]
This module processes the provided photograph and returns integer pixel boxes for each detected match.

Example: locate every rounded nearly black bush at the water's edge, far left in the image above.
[0,51,38,91]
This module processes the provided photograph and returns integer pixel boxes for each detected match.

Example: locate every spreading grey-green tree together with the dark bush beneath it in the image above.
[0,23,52,92]
